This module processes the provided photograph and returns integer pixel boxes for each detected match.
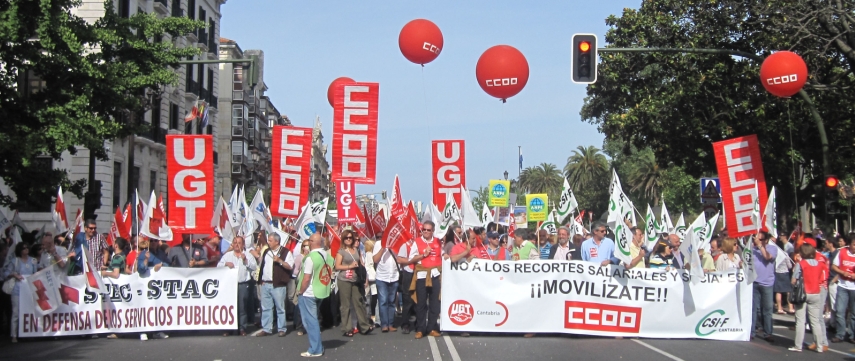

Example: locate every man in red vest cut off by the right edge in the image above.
[831,237,855,343]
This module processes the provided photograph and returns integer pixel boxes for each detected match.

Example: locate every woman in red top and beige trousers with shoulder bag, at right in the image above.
[790,243,828,352]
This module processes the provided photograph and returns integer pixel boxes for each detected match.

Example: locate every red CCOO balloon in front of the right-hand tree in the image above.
[760,51,807,98]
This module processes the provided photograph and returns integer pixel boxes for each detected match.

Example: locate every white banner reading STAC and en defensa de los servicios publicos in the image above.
[18,267,237,337]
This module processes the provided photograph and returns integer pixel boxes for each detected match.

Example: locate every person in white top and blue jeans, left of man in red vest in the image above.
[373,236,404,332]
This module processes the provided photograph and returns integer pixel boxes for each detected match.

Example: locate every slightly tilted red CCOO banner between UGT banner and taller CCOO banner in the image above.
[270,125,312,218]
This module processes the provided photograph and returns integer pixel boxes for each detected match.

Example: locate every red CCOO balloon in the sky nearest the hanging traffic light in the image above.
[475,45,528,101]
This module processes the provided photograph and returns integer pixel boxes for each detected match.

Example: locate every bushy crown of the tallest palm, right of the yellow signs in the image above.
[564,145,610,189]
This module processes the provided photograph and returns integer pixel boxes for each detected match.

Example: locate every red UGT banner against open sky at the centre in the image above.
[431,140,466,212]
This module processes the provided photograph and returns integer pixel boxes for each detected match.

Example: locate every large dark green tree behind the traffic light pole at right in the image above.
[581,0,855,224]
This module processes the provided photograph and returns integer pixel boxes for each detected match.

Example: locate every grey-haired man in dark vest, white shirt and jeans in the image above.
[256,233,294,337]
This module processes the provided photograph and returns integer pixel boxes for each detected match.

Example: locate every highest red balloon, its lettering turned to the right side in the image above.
[398,19,442,66]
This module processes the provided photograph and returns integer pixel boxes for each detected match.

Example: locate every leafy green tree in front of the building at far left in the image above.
[0,0,204,208]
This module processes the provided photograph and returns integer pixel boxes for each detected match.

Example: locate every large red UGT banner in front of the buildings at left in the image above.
[167,135,215,232]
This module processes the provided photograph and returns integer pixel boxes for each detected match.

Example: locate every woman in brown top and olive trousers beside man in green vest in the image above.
[335,229,374,337]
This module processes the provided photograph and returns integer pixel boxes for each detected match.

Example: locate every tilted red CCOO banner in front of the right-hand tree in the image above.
[713,134,768,237]
